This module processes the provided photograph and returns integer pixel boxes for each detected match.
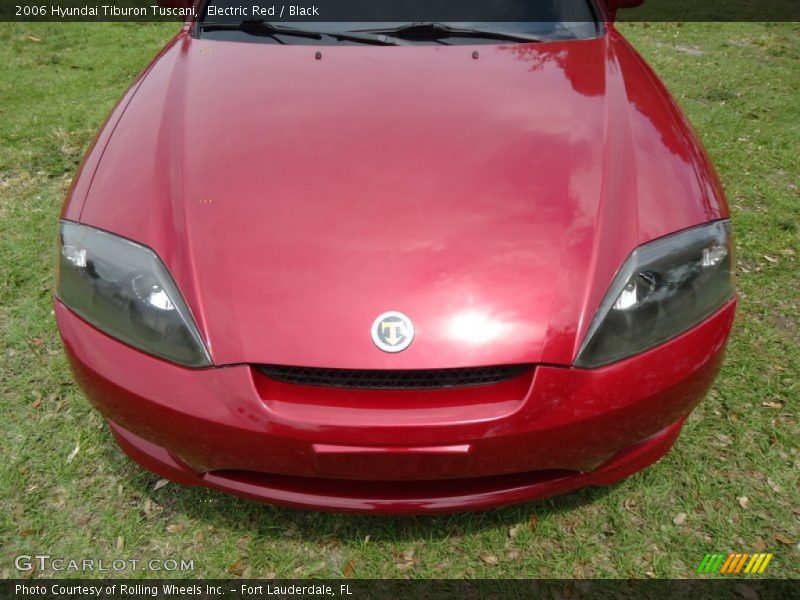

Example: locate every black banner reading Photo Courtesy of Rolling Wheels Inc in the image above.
[0,577,798,600]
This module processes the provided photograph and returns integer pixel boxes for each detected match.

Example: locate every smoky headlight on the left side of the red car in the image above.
[56,221,211,367]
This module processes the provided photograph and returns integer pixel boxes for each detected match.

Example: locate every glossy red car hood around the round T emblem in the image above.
[81,32,725,368]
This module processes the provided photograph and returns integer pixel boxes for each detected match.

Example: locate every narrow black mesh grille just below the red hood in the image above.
[258,365,532,390]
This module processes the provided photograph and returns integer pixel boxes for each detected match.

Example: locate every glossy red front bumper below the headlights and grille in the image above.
[55,301,734,513]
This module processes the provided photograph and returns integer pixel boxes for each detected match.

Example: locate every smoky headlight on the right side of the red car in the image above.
[575,221,733,367]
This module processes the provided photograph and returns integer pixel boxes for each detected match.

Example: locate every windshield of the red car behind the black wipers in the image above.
[196,0,601,45]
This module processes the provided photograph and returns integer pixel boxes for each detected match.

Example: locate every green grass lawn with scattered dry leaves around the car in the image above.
[0,23,800,578]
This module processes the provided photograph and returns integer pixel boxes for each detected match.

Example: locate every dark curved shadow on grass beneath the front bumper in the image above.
[102,435,617,544]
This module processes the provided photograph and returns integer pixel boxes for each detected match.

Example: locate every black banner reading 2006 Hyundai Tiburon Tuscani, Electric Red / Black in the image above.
[0,0,800,23]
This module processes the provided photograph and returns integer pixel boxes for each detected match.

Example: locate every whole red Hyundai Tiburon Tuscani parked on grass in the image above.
[55,0,735,513]
